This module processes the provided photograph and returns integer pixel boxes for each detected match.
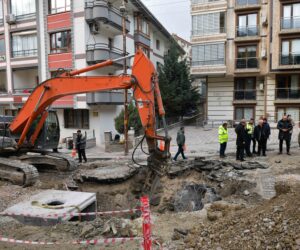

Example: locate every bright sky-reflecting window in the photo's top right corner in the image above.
[281,3,300,29]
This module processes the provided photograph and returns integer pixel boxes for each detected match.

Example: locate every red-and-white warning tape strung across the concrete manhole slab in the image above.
[0,208,141,219]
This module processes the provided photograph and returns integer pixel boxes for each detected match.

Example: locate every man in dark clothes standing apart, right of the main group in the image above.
[277,115,293,155]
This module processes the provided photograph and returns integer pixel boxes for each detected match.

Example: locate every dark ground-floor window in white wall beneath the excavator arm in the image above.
[64,109,90,129]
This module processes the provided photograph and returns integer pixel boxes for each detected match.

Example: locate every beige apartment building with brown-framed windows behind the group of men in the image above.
[191,0,300,121]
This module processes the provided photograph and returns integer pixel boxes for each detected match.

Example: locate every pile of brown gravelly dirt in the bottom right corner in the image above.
[168,183,300,250]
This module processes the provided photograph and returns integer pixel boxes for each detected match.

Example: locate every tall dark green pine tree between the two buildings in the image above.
[158,44,200,117]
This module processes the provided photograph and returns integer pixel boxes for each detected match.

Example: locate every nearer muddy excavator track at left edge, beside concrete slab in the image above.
[0,157,39,187]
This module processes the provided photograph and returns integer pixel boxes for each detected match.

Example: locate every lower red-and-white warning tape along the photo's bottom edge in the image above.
[0,236,144,245]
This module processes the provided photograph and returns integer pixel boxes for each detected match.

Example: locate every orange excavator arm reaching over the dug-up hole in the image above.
[10,51,170,158]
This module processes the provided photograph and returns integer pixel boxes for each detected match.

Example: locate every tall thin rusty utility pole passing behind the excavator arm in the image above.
[120,0,129,155]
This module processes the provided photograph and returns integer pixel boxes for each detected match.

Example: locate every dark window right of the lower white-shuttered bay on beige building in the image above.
[236,45,258,69]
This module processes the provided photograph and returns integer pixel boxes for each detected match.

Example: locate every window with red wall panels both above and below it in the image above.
[50,30,71,53]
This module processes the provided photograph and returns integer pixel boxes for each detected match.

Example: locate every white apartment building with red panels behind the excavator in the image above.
[0,0,178,145]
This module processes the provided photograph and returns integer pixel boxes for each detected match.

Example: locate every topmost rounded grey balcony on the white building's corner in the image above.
[85,0,130,32]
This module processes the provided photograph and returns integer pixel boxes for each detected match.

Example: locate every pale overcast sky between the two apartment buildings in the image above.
[142,0,191,41]
